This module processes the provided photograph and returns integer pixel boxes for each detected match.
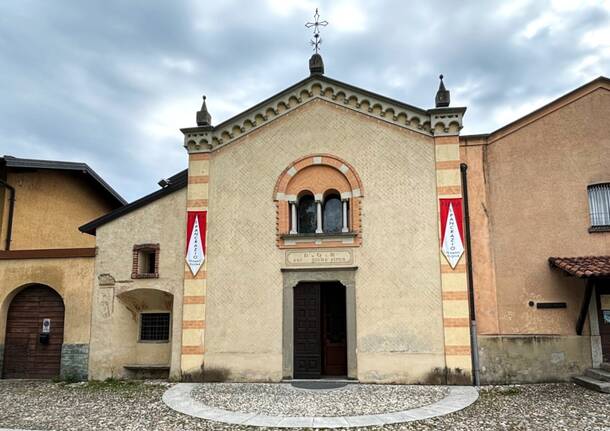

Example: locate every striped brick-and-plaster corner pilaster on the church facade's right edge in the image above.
[434,129,472,384]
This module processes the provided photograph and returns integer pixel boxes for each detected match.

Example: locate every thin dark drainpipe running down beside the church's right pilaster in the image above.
[460,163,481,386]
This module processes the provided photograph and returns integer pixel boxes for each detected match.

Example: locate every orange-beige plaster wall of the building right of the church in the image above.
[462,83,610,335]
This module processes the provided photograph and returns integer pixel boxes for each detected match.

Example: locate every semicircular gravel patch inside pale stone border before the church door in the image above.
[191,383,448,416]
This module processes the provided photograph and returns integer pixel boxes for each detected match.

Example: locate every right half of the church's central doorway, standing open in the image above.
[321,283,347,376]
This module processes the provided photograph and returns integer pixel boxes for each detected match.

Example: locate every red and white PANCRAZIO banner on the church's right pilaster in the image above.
[440,198,464,268]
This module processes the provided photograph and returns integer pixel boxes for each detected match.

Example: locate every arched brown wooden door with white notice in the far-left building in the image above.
[2,285,64,379]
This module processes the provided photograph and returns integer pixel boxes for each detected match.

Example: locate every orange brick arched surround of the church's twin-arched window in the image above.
[273,154,364,248]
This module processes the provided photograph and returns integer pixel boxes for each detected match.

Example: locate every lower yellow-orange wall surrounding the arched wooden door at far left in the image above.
[0,258,94,344]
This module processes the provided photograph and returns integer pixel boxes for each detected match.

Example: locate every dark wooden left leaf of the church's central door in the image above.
[294,283,322,379]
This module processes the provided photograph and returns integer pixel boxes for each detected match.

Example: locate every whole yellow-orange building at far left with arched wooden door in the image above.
[0,156,125,378]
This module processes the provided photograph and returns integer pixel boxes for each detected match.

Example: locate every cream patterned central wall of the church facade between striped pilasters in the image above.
[205,100,444,382]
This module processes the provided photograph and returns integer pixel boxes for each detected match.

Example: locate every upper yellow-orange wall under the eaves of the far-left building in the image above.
[1,170,112,250]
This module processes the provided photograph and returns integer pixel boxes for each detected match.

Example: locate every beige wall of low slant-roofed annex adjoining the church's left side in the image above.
[89,188,186,379]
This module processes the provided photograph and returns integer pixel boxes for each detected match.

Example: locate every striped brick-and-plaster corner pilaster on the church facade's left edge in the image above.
[180,152,210,380]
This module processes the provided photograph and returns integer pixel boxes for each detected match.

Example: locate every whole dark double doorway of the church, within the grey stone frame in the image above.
[294,282,347,379]
